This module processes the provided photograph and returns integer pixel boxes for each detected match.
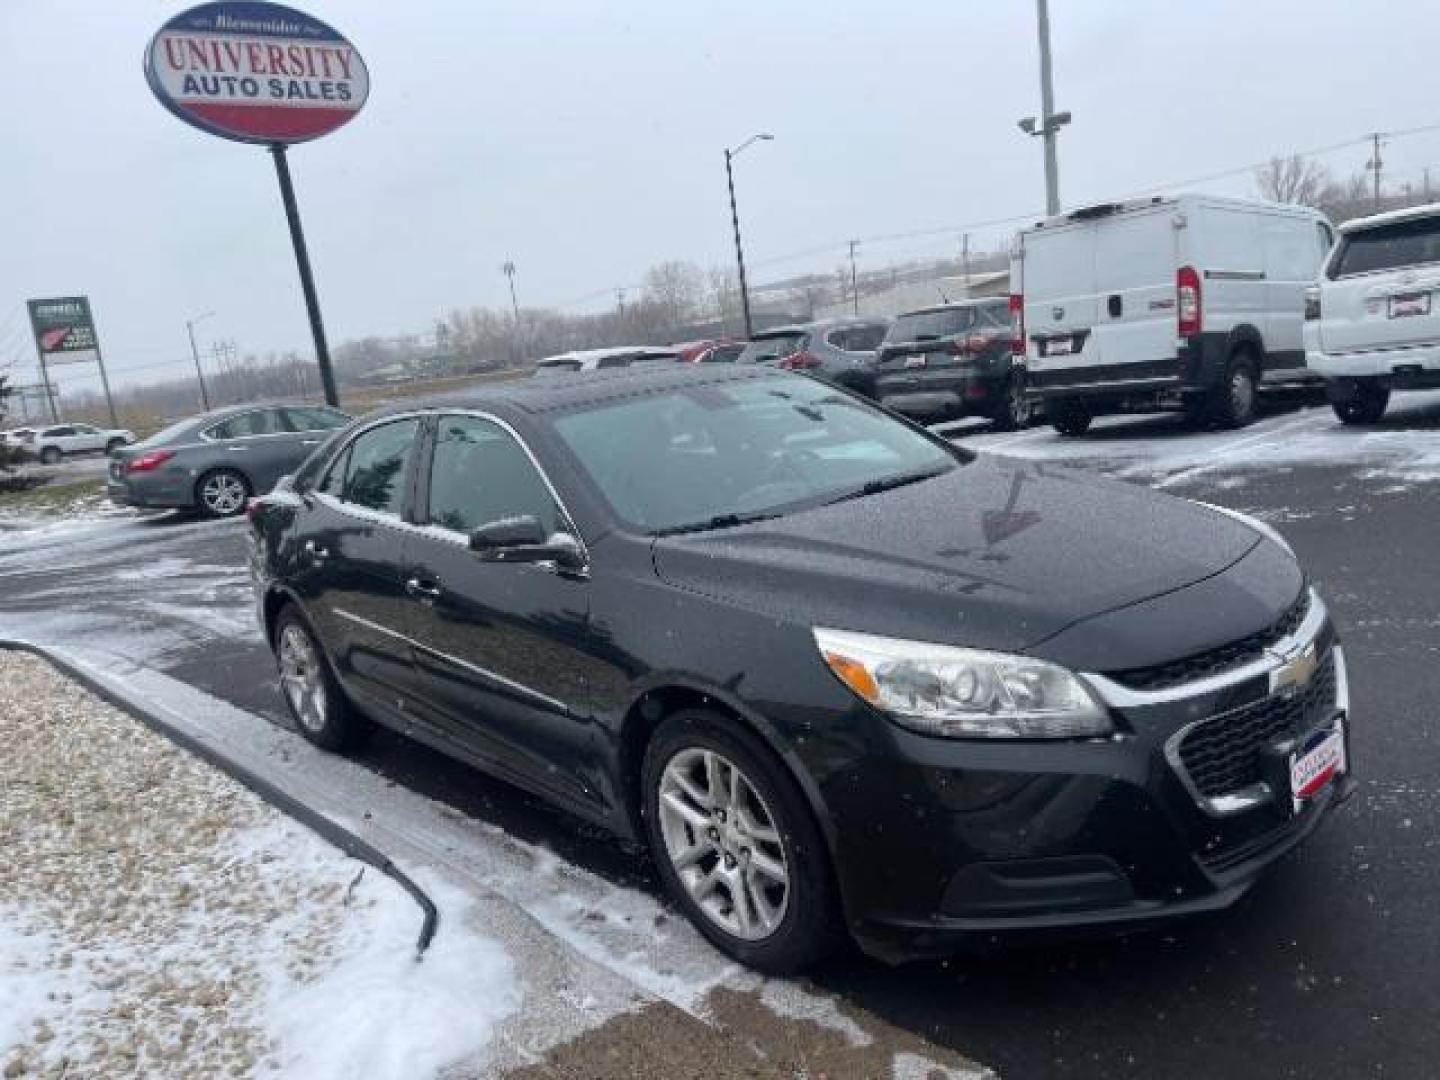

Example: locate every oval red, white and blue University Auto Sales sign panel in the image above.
[145,0,370,145]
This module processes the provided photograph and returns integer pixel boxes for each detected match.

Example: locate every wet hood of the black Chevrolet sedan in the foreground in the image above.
[654,455,1267,667]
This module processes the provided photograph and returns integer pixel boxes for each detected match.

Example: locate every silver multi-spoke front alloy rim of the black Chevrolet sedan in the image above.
[658,747,791,942]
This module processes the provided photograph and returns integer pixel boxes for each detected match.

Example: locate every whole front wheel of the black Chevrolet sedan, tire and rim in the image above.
[641,708,840,975]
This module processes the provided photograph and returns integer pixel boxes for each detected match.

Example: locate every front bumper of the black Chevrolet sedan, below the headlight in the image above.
[824,598,1354,960]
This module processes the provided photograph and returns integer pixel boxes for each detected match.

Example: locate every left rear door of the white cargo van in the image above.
[1020,222,1103,384]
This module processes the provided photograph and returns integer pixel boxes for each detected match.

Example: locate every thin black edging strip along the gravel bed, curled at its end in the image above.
[0,638,441,960]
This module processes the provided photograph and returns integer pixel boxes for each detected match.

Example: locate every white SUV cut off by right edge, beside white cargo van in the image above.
[1305,203,1440,423]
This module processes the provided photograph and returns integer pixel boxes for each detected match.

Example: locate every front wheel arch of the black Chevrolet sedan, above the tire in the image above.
[618,674,837,863]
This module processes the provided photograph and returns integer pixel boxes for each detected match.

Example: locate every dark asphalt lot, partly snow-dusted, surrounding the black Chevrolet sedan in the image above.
[0,395,1440,1077]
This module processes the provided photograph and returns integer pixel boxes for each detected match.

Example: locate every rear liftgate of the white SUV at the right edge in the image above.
[1320,216,1440,353]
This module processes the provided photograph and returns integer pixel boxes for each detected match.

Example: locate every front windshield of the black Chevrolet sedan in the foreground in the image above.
[554,377,963,533]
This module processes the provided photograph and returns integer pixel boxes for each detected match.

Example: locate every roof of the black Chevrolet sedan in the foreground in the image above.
[366,364,801,420]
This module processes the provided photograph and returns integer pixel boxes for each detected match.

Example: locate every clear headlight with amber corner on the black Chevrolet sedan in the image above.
[814,626,1113,739]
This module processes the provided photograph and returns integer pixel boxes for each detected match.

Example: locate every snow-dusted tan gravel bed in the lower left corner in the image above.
[0,651,383,1077]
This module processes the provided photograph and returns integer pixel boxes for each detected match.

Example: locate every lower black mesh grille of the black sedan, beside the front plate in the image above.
[1179,651,1335,798]
